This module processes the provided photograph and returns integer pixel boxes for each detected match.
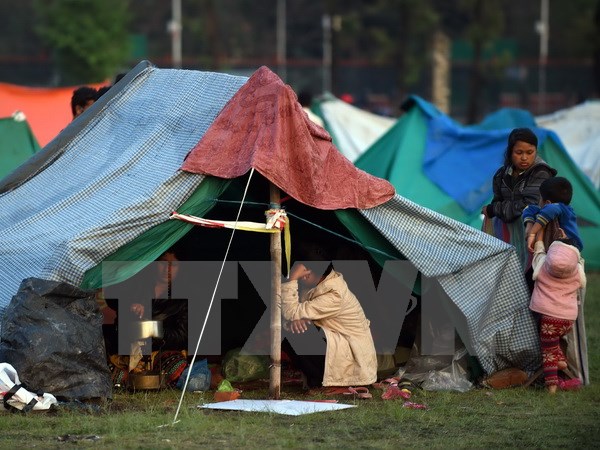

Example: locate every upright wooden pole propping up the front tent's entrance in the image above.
[269,183,281,400]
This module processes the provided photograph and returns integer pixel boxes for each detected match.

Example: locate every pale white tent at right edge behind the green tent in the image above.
[535,100,600,189]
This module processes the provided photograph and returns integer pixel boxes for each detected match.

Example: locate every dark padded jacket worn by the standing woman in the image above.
[486,157,556,223]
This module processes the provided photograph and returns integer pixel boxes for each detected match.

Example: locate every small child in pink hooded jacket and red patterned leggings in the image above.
[529,230,586,394]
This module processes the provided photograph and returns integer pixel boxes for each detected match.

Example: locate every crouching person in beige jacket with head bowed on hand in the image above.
[281,244,377,395]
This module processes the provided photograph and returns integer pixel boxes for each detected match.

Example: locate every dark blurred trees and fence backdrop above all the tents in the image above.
[0,0,600,122]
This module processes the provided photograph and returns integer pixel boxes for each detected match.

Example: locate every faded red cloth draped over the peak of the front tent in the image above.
[181,66,395,209]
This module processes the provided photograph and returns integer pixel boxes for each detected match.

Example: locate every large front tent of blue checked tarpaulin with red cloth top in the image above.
[0,62,540,373]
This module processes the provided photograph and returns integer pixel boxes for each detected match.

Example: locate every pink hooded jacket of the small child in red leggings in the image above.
[529,241,581,320]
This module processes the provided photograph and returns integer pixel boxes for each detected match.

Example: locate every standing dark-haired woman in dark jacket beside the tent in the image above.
[481,128,556,271]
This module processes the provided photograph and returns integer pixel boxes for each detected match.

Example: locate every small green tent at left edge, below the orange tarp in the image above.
[0,112,40,179]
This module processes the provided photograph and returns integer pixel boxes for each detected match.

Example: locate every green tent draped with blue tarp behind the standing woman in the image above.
[355,96,600,269]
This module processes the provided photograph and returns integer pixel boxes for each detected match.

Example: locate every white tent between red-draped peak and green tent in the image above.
[314,94,396,161]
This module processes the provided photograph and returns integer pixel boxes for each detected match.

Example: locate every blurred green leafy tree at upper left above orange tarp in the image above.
[35,0,130,84]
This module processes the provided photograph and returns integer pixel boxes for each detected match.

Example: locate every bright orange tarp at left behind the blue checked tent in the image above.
[0,79,106,147]
